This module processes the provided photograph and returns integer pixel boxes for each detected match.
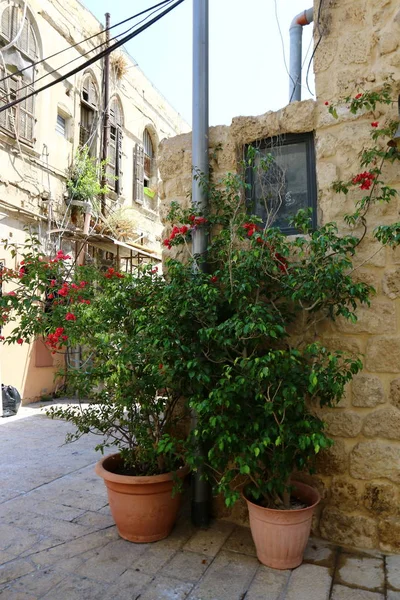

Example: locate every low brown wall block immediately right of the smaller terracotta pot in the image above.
[320,506,378,548]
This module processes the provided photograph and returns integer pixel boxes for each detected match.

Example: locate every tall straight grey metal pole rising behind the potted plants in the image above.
[192,0,211,527]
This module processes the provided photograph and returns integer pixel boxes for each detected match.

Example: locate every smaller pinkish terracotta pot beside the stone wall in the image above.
[245,482,321,569]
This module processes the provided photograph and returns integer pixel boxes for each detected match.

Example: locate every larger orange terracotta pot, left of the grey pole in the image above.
[95,454,189,543]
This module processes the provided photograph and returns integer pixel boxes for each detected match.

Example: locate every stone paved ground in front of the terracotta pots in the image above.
[0,406,400,600]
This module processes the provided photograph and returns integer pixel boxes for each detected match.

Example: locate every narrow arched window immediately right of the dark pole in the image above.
[106,98,123,194]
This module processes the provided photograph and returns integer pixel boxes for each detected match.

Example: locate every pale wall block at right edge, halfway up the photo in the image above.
[335,301,396,334]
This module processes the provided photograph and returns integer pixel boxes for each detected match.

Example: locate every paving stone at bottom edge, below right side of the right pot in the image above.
[285,564,331,600]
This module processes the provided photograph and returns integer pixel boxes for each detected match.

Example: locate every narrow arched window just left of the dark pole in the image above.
[79,73,99,156]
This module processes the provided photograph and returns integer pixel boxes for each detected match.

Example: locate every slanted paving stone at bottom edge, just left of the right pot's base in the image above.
[188,550,259,600]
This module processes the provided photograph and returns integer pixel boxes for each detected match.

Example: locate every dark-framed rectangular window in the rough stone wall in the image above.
[246,133,317,234]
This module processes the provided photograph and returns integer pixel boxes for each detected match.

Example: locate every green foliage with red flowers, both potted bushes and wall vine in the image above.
[0,82,400,506]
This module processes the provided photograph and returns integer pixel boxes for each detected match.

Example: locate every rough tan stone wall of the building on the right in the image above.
[160,0,400,552]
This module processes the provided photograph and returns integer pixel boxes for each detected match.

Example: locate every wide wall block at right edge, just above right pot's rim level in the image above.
[350,441,400,483]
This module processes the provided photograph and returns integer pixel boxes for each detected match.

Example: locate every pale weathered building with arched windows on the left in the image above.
[0,0,189,400]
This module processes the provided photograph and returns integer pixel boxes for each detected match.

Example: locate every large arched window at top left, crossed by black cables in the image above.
[0,0,39,143]
